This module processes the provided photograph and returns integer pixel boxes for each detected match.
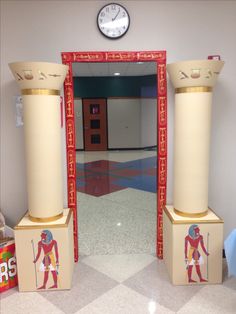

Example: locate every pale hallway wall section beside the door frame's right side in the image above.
[140,98,157,147]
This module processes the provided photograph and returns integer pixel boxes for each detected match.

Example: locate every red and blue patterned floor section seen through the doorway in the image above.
[76,156,156,196]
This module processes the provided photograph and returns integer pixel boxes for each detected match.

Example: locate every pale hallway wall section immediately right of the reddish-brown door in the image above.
[107,98,141,148]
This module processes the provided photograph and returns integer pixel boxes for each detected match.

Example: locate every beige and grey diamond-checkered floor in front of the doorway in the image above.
[0,254,236,314]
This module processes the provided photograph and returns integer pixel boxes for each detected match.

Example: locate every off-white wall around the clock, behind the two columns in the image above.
[0,0,236,235]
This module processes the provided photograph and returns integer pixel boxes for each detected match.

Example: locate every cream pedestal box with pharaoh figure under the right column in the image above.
[163,206,223,285]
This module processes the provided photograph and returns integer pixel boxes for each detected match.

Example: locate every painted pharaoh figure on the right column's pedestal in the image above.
[184,225,209,283]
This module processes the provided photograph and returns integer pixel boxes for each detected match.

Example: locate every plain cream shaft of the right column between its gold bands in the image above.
[174,92,212,214]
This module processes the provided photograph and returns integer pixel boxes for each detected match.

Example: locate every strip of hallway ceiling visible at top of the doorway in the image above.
[72,62,157,76]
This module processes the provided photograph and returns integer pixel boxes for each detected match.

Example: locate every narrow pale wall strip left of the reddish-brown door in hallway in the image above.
[74,99,84,149]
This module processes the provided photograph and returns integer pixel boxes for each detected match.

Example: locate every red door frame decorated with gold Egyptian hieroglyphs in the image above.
[61,51,167,261]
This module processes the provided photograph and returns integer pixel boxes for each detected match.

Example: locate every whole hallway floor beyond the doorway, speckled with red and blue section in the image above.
[77,151,156,256]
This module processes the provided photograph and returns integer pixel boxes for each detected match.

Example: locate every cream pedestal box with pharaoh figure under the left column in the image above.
[14,209,74,291]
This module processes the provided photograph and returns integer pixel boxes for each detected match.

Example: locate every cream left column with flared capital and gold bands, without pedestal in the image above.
[9,62,68,221]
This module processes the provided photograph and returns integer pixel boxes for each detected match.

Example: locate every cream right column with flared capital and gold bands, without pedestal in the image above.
[167,60,224,217]
